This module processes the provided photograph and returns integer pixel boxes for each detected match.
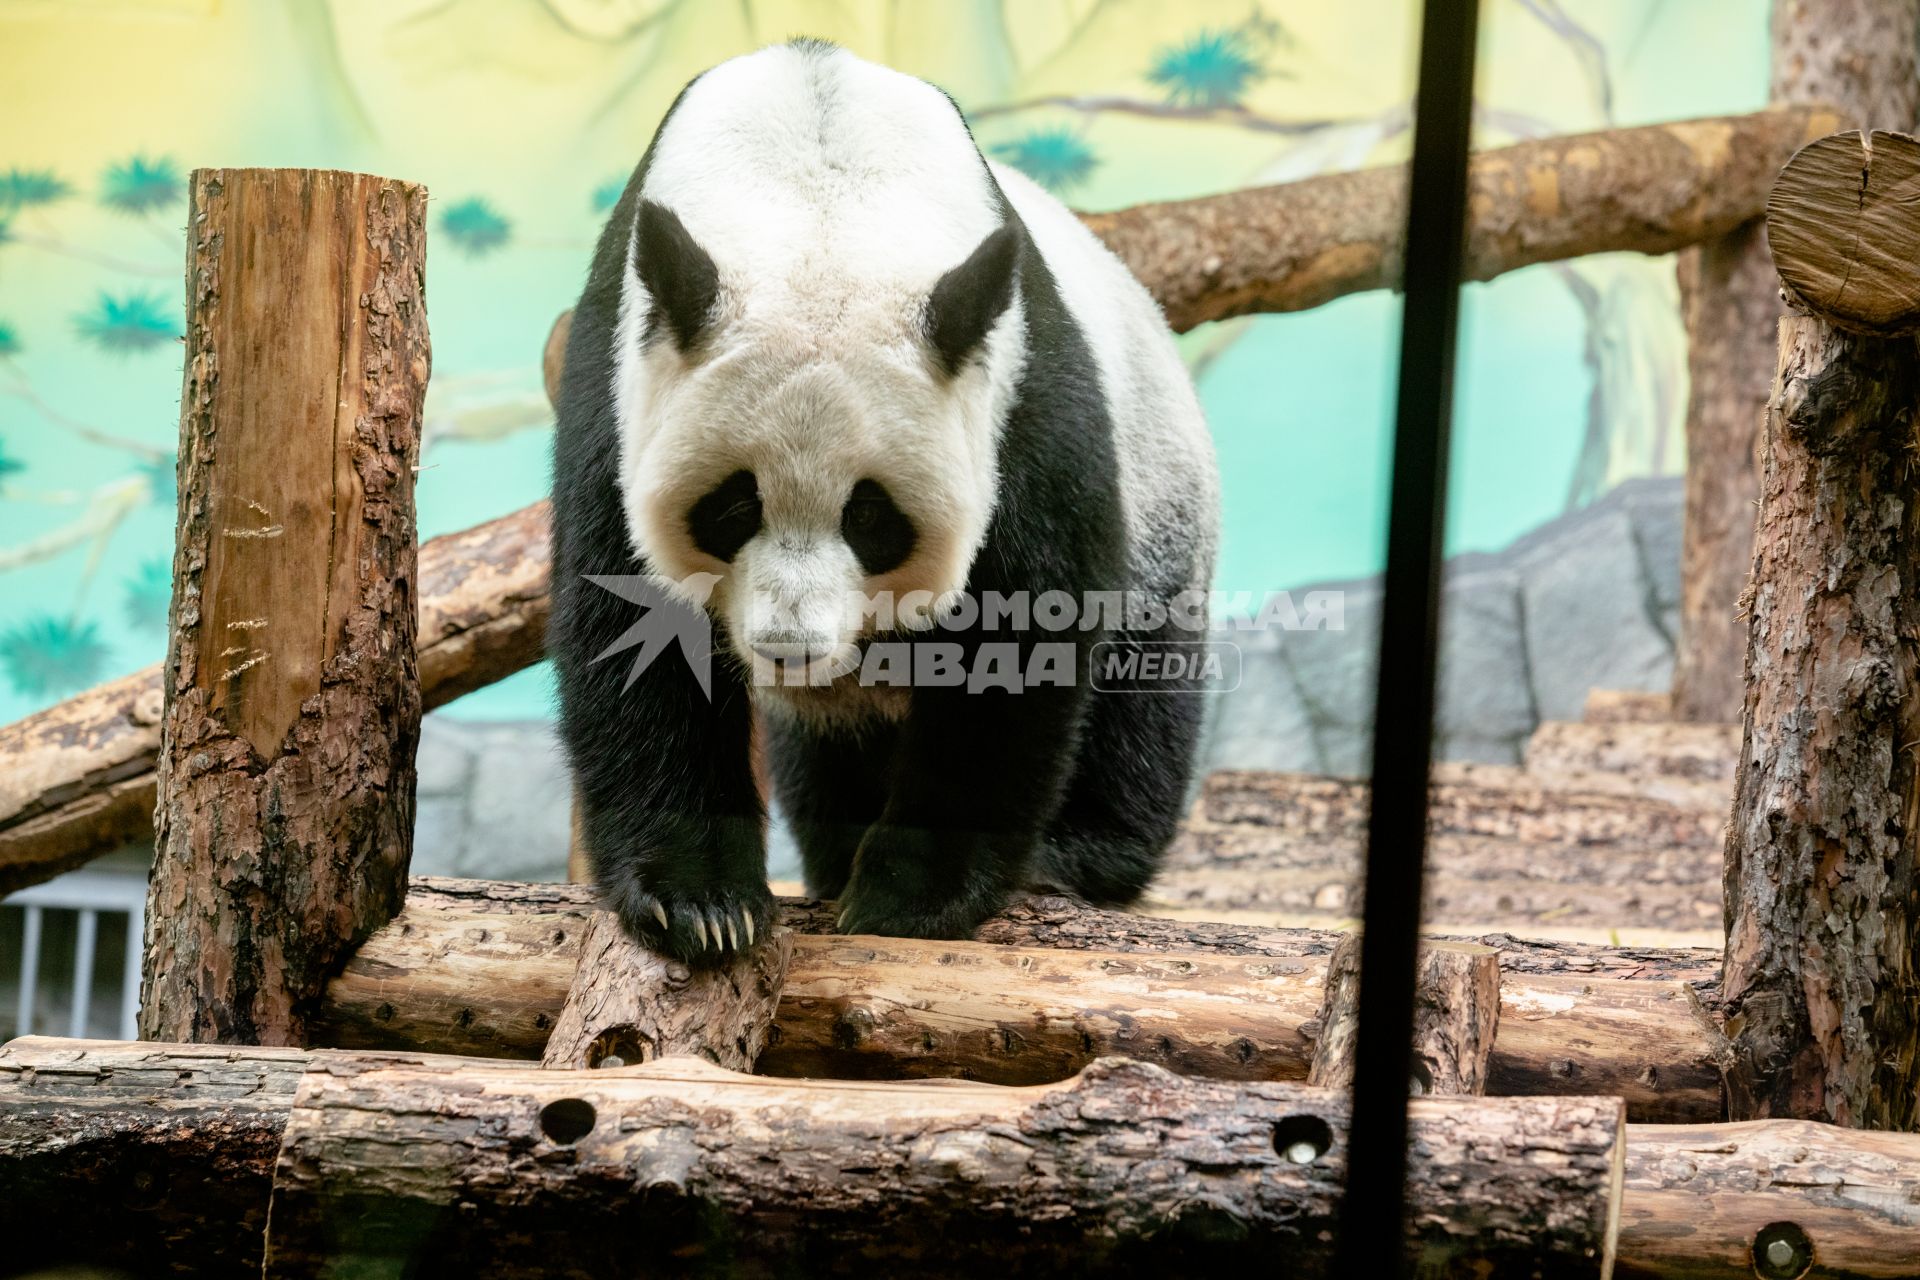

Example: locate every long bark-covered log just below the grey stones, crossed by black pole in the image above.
[1200,766,1726,848]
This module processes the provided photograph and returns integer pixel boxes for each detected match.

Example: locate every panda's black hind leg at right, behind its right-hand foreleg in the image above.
[1033,651,1206,906]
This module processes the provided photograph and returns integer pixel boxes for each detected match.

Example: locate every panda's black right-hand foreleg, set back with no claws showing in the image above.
[839,671,1087,938]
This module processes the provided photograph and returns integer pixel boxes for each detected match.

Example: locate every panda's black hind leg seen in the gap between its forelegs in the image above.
[764,712,899,898]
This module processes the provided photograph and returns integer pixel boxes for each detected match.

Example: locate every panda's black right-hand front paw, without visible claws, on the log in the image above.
[839,823,1008,938]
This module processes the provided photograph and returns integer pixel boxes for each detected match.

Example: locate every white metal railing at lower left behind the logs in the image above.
[0,867,146,1040]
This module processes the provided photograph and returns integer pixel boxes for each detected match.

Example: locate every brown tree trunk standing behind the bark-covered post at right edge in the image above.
[1674,0,1920,723]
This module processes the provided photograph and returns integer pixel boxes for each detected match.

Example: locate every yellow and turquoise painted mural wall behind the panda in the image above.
[0,0,1766,722]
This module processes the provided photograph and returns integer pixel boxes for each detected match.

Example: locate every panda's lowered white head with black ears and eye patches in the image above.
[616,200,1027,683]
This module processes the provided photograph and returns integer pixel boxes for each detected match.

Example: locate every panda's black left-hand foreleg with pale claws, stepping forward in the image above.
[551,574,774,961]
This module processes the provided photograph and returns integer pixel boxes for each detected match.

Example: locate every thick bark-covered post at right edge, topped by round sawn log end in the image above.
[1724,132,1920,1128]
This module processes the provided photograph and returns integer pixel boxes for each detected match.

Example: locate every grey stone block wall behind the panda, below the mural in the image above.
[413,480,1680,879]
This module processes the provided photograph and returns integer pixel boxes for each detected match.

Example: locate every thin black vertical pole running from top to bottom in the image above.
[1334,0,1478,1278]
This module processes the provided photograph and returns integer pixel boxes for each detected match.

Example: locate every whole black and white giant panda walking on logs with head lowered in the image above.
[549,40,1217,961]
